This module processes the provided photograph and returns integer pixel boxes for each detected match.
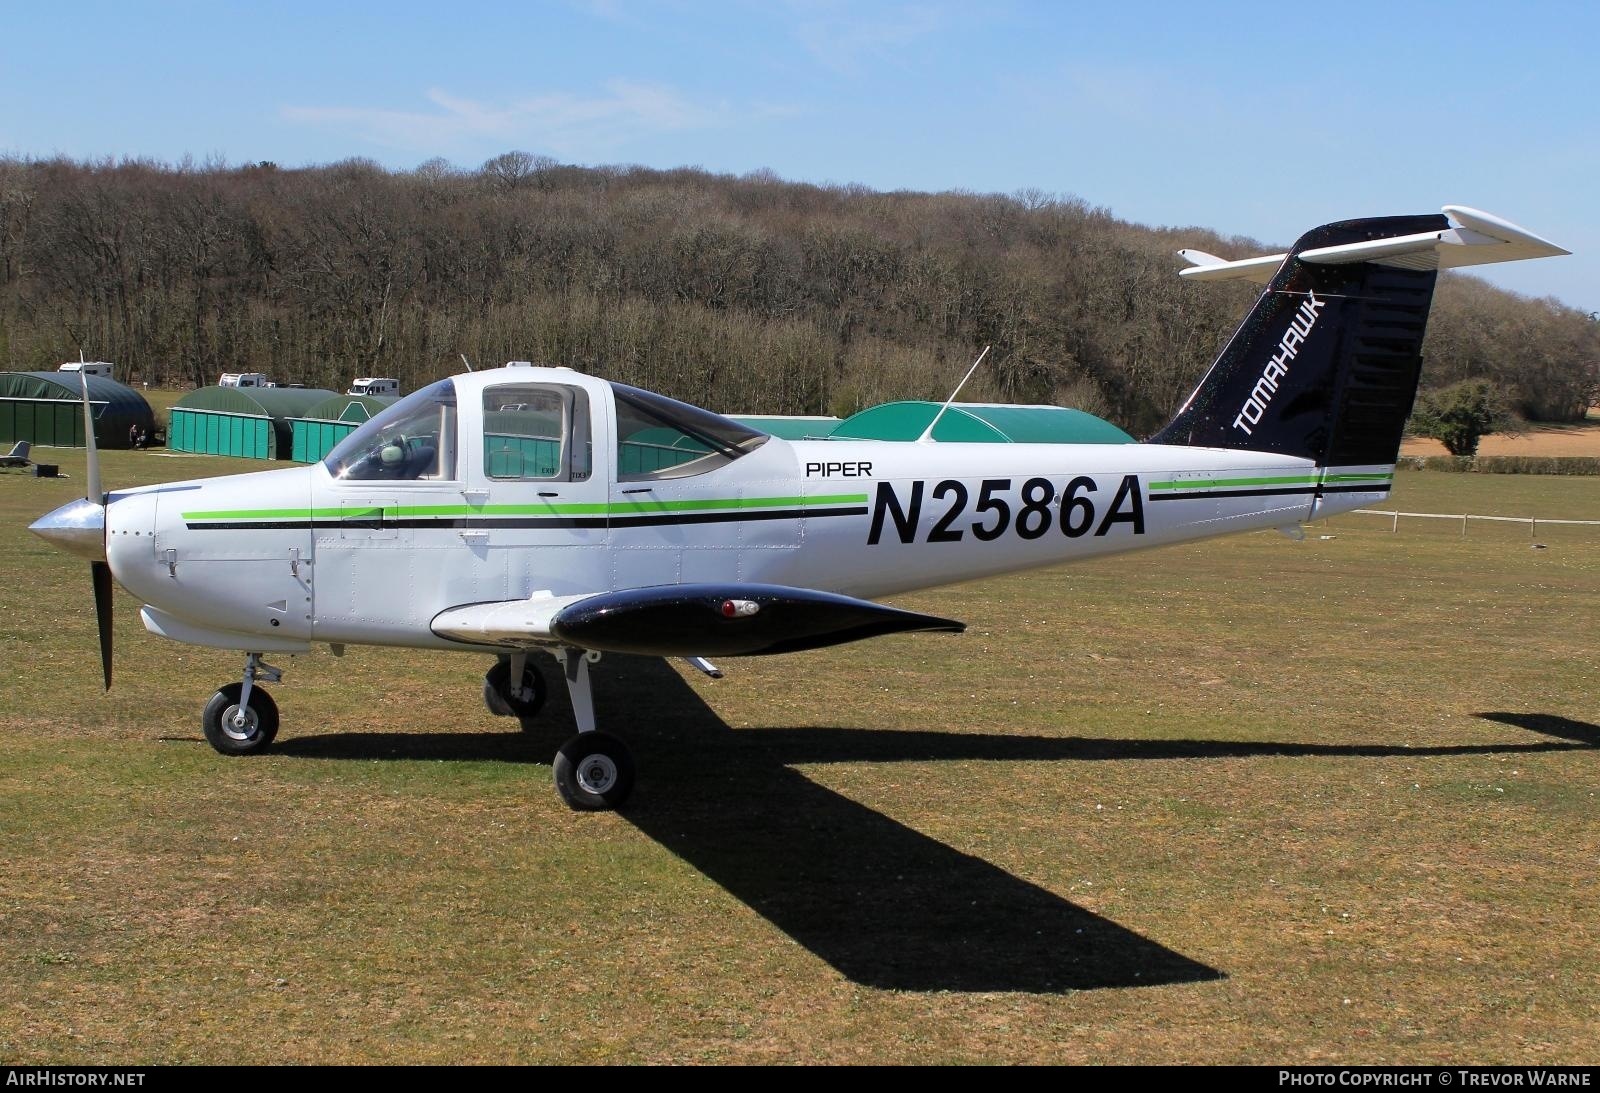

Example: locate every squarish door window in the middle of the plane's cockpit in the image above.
[483,384,592,482]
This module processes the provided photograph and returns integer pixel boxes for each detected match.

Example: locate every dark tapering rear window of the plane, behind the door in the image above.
[611,384,768,482]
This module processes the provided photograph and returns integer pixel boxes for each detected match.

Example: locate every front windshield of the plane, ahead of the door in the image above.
[322,379,456,482]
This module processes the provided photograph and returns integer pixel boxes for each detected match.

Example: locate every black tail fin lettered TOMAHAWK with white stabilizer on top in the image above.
[1150,205,1568,505]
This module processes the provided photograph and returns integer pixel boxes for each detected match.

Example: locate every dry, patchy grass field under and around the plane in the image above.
[0,450,1600,1063]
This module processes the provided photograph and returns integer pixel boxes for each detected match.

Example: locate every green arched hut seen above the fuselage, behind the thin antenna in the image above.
[827,402,1134,443]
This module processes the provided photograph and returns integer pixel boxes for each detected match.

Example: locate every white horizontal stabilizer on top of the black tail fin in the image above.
[1178,205,1571,285]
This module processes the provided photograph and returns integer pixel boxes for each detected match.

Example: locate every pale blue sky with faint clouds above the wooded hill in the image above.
[0,0,1600,310]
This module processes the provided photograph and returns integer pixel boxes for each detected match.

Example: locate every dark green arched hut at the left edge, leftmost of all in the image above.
[0,371,155,448]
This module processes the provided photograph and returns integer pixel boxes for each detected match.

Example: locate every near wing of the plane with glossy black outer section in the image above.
[432,583,966,656]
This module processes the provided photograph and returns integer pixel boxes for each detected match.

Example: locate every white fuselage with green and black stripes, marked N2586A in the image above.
[107,370,1392,651]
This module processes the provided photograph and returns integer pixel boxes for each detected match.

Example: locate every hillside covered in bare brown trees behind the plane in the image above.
[0,152,1600,434]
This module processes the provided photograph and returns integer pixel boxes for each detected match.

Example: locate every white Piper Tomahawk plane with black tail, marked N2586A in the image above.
[32,206,1566,808]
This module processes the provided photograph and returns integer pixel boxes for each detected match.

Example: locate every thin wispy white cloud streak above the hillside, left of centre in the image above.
[282,80,736,160]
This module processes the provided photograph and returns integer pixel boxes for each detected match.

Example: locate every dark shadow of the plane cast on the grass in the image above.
[275,656,1600,992]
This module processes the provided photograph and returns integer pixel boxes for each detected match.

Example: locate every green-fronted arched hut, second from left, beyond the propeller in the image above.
[166,387,333,459]
